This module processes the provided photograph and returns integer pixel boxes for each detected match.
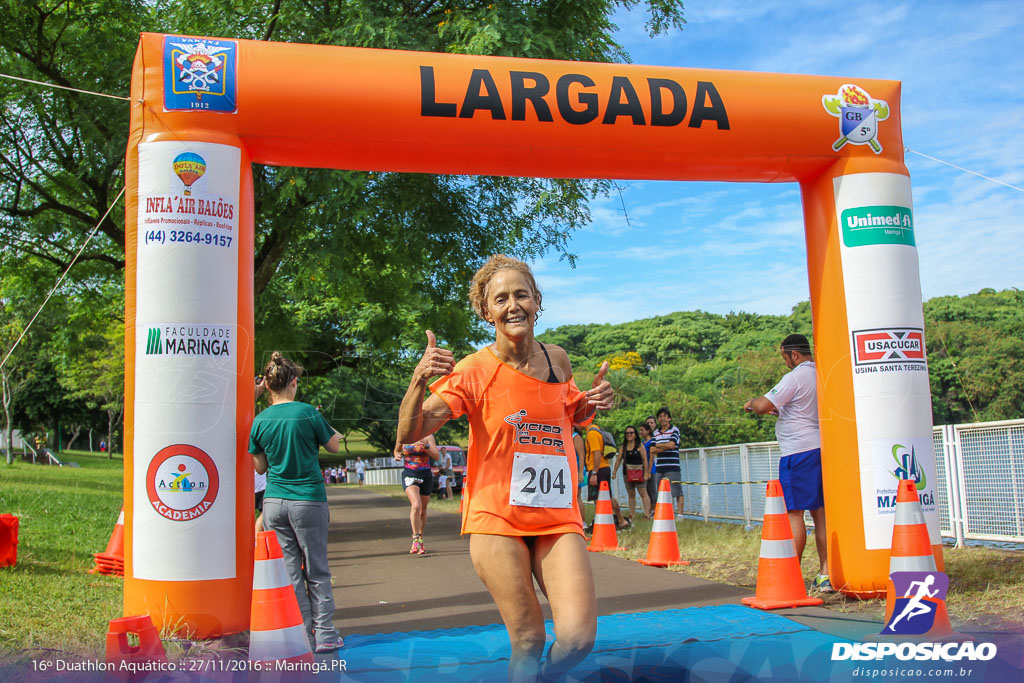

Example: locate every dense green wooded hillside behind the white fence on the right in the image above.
[541,290,1024,447]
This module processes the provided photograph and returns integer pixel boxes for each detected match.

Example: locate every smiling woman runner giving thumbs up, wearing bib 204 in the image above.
[398,255,613,680]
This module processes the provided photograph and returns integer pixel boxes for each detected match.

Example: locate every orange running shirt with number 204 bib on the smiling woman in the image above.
[430,348,584,536]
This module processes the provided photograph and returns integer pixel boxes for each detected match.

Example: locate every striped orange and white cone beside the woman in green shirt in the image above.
[249,531,313,661]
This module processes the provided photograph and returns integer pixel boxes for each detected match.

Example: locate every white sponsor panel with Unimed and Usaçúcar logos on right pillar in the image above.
[834,173,940,550]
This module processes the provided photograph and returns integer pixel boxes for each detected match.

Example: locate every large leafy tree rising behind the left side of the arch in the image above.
[0,0,683,449]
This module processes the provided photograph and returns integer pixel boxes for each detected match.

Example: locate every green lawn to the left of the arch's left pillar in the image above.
[0,451,123,660]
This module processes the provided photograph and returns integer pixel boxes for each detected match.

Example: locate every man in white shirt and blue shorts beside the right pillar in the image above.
[743,335,833,593]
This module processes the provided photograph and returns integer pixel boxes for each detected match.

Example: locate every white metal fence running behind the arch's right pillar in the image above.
[612,420,1024,545]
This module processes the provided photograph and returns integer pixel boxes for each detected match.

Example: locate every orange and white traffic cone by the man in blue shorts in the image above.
[741,479,821,609]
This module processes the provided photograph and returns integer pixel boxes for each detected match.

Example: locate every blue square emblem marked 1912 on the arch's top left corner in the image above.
[164,36,238,114]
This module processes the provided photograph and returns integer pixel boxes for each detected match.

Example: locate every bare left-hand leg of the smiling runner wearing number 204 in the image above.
[469,533,552,681]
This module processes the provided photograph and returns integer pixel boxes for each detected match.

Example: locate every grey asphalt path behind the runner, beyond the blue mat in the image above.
[319,486,751,636]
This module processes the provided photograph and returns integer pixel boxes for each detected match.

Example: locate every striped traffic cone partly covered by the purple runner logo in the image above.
[872,479,973,641]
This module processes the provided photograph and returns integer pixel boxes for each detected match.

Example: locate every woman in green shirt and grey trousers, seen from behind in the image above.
[249,351,344,652]
